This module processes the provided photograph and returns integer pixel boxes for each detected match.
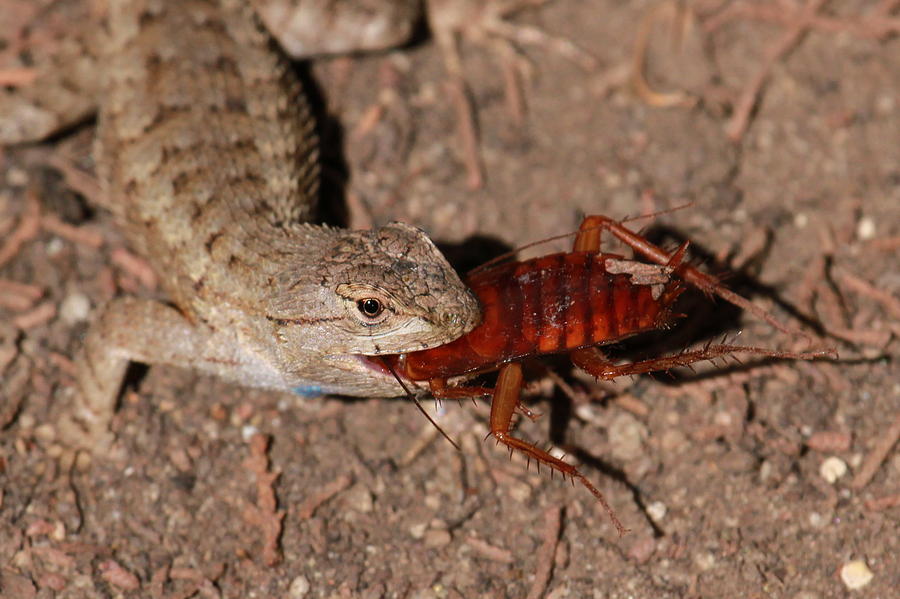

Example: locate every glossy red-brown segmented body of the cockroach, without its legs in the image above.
[405,252,678,380]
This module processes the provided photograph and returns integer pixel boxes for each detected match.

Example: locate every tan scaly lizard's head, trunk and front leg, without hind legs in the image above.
[1,0,480,448]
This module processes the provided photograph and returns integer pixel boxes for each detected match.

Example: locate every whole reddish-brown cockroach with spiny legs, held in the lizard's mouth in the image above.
[372,216,833,535]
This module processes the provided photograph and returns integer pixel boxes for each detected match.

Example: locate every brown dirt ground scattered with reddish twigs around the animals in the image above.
[0,0,900,599]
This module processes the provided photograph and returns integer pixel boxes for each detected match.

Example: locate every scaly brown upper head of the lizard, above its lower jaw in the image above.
[268,223,481,356]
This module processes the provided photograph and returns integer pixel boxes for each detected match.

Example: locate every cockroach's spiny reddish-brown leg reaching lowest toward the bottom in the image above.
[491,362,627,536]
